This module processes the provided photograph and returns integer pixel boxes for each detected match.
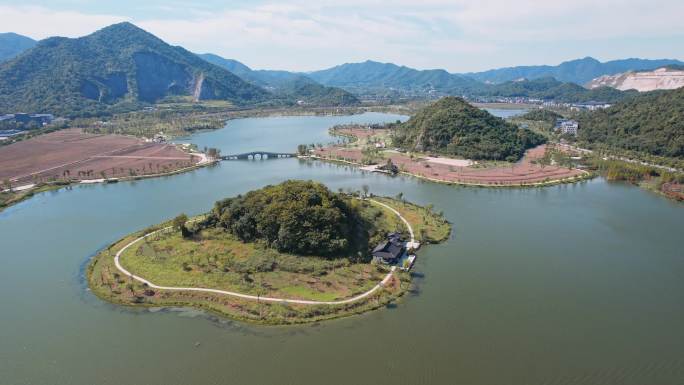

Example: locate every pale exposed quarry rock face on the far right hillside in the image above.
[587,68,684,92]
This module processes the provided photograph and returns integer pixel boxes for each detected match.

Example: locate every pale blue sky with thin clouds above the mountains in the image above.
[0,0,684,72]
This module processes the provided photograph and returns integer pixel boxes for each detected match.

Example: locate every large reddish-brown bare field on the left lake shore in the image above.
[0,129,200,184]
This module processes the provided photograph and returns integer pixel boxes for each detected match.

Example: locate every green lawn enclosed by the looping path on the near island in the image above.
[121,199,420,301]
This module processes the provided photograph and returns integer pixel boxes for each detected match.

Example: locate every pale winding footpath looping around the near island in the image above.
[114,199,415,305]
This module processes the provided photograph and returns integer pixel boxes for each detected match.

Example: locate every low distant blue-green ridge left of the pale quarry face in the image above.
[476,77,636,103]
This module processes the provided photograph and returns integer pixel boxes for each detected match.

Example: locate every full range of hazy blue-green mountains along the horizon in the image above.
[0,23,684,111]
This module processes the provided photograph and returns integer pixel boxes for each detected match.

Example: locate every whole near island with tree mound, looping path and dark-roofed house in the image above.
[87,180,451,324]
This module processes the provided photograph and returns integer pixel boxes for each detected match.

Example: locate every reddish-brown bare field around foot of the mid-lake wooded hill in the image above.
[316,145,583,186]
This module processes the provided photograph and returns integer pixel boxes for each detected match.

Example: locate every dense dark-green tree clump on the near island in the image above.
[208,181,359,256]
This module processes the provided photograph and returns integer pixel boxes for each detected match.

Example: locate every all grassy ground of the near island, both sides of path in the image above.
[88,198,450,324]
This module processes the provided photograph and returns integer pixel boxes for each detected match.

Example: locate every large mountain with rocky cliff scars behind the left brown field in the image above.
[0,23,270,116]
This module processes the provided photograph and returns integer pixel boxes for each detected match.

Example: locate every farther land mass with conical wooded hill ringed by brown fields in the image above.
[308,97,592,187]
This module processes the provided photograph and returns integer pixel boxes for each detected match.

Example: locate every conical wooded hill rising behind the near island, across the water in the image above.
[394,97,544,161]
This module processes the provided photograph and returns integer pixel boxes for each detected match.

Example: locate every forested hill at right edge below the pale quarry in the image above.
[578,88,684,159]
